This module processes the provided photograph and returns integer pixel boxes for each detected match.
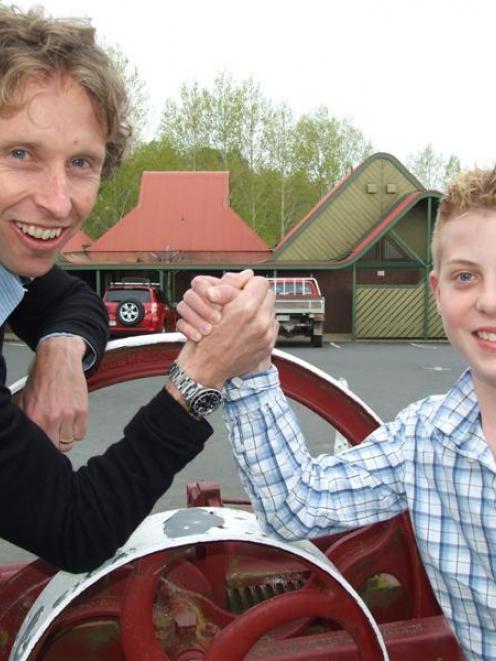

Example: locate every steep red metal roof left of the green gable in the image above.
[70,172,271,264]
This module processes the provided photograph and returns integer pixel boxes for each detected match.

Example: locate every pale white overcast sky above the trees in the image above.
[13,0,496,167]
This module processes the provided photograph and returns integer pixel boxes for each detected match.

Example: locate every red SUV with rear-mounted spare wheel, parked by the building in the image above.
[103,279,176,335]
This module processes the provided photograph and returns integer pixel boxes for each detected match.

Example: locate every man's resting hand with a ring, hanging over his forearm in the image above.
[14,335,88,452]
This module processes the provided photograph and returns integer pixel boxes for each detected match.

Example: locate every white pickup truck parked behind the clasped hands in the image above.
[268,278,325,347]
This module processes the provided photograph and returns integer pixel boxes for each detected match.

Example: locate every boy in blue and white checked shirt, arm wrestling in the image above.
[183,170,496,661]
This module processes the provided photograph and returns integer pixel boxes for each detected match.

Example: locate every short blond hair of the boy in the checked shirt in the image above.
[431,168,496,270]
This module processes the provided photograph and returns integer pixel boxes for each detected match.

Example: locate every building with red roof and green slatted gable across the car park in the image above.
[63,153,444,338]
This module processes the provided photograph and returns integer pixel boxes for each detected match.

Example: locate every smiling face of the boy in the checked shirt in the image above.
[430,209,496,387]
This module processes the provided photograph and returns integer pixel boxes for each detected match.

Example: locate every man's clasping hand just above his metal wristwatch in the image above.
[174,277,278,388]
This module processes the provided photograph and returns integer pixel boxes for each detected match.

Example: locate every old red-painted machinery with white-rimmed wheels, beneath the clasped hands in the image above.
[0,335,463,661]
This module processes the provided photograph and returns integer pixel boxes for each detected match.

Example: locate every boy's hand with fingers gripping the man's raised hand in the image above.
[177,269,254,342]
